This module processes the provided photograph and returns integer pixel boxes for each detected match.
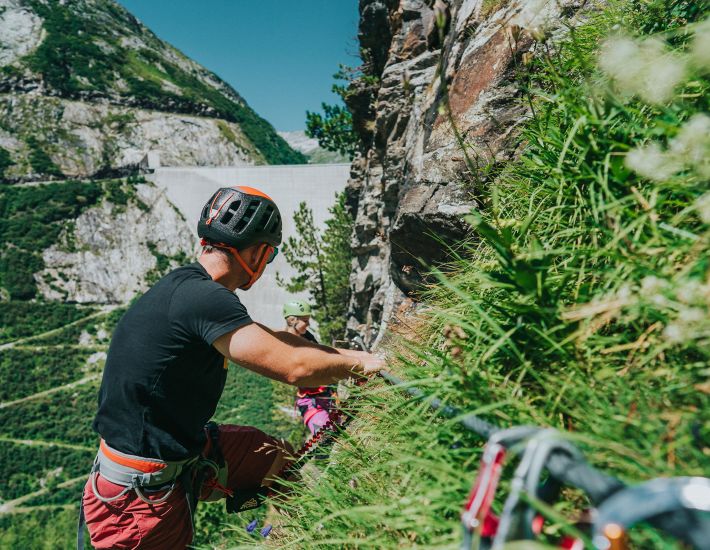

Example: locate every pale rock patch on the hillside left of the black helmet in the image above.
[35,184,197,304]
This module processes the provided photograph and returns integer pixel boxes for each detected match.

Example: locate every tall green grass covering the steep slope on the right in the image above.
[235,2,710,548]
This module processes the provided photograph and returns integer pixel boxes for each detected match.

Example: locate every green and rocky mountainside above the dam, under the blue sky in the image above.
[0,0,305,179]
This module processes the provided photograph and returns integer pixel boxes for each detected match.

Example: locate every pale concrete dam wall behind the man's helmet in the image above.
[150,164,350,334]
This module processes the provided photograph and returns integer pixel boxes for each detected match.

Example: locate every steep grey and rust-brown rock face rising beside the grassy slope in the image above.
[347,0,584,341]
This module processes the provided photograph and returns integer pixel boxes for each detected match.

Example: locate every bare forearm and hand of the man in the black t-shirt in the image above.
[214,323,382,386]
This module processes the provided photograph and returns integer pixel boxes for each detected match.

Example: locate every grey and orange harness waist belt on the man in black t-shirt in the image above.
[96,439,199,487]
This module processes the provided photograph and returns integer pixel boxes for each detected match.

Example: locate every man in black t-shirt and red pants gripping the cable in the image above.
[79,187,382,549]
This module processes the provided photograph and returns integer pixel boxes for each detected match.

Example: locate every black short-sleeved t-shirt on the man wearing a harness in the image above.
[94,263,252,460]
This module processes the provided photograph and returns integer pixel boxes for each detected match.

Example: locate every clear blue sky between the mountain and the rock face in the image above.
[118,0,359,130]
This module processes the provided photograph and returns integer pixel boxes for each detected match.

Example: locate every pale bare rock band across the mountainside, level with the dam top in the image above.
[0,94,265,177]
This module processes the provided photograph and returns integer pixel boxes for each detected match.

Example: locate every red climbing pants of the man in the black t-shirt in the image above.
[84,425,290,550]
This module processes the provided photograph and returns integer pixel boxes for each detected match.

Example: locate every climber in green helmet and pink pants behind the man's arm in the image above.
[283,300,335,435]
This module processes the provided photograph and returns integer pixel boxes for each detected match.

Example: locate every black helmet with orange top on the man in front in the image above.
[197,186,281,250]
